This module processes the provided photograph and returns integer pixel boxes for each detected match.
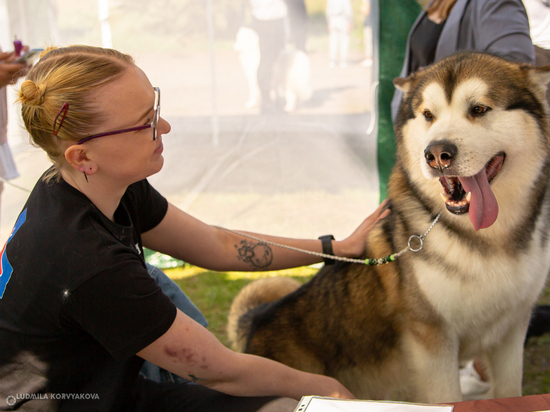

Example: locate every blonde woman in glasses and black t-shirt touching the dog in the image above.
[0,46,388,411]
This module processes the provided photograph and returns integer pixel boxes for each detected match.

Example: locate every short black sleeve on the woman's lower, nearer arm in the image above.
[64,259,176,360]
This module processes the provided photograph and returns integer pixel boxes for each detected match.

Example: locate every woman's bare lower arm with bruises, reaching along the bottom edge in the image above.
[137,311,353,399]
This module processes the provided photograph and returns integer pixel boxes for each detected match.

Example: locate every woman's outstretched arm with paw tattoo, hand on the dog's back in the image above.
[142,203,389,271]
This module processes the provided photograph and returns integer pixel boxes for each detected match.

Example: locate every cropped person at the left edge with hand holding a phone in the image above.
[0,51,27,230]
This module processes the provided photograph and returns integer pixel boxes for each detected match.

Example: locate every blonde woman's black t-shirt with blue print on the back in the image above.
[0,171,176,411]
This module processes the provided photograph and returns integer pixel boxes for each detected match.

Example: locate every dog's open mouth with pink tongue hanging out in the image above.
[439,153,506,231]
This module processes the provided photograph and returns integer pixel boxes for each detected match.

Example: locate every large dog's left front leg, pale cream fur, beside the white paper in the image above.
[403,326,462,403]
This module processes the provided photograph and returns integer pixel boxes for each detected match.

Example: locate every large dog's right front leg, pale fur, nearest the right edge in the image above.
[487,313,529,398]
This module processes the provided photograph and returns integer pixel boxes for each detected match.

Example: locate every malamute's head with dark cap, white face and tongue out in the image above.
[394,52,550,231]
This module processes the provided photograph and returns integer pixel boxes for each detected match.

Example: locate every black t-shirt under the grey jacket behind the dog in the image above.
[409,15,445,73]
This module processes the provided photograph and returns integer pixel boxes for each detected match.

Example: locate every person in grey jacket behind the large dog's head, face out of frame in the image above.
[392,0,535,121]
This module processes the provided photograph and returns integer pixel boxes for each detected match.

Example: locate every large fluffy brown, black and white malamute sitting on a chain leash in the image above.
[228,52,550,403]
